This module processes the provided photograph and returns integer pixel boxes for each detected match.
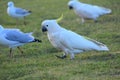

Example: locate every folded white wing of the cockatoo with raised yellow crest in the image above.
[60,30,108,51]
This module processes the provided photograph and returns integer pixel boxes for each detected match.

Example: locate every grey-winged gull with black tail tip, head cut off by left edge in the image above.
[0,25,41,57]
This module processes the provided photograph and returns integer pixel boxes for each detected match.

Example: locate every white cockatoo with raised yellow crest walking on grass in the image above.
[41,14,109,59]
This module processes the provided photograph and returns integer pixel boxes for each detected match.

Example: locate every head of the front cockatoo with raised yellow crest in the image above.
[41,15,63,33]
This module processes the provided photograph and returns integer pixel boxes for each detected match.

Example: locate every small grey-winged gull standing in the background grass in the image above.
[7,1,31,24]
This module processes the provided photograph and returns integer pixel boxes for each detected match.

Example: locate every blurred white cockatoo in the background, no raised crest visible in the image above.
[68,0,112,23]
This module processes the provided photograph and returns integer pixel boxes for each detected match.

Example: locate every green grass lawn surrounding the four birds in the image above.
[0,0,120,80]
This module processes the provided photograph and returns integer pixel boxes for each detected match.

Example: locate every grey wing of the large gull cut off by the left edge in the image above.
[5,30,34,43]
